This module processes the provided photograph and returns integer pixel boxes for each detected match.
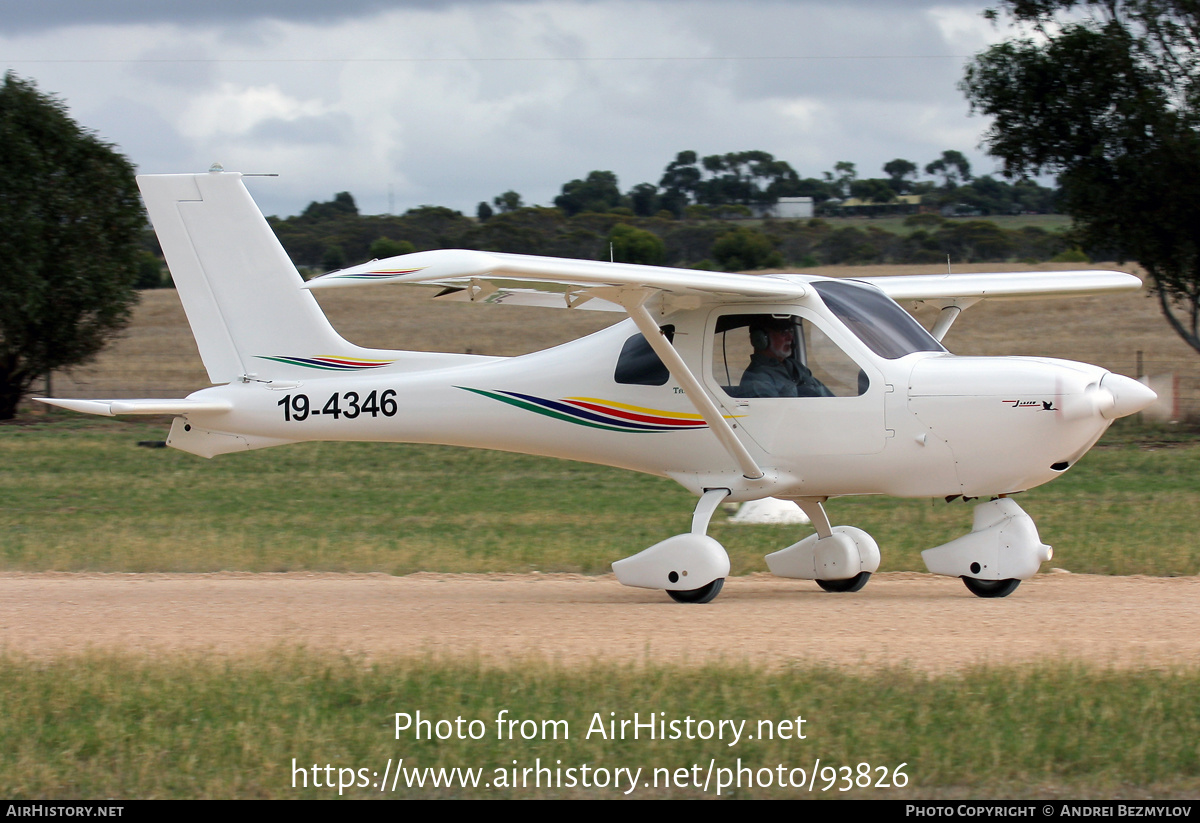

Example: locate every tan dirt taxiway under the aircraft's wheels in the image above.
[0,572,1200,672]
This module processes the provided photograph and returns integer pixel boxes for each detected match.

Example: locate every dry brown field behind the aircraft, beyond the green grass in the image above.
[34,264,1200,417]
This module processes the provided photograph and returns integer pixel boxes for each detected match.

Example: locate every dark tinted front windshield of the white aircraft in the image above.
[812,280,946,360]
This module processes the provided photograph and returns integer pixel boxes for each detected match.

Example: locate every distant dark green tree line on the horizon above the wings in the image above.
[258,150,1070,271]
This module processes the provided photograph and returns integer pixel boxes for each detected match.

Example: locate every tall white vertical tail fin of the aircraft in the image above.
[138,172,369,383]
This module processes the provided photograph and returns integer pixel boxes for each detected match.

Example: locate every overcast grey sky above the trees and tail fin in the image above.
[0,0,1004,216]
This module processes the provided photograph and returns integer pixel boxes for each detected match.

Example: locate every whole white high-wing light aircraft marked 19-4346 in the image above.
[44,167,1154,602]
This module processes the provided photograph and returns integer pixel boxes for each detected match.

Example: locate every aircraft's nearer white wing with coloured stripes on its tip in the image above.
[305,248,811,312]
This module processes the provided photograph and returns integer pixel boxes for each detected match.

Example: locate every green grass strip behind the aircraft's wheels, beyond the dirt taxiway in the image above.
[7,420,1200,576]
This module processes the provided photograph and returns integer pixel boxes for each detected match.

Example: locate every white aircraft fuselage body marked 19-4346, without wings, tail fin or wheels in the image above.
[172,298,1127,499]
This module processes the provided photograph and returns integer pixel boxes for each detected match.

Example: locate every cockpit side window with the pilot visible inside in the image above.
[713,314,869,397]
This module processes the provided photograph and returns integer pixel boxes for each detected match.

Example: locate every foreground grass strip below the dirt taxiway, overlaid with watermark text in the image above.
[0,651,1200,799]
